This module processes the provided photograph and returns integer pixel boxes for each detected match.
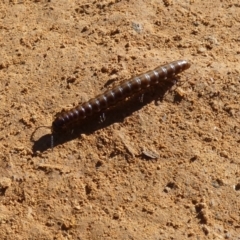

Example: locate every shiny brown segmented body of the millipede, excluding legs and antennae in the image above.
[52,60,190,133]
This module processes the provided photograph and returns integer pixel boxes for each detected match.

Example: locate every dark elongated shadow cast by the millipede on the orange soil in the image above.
[32,78,182,154]
